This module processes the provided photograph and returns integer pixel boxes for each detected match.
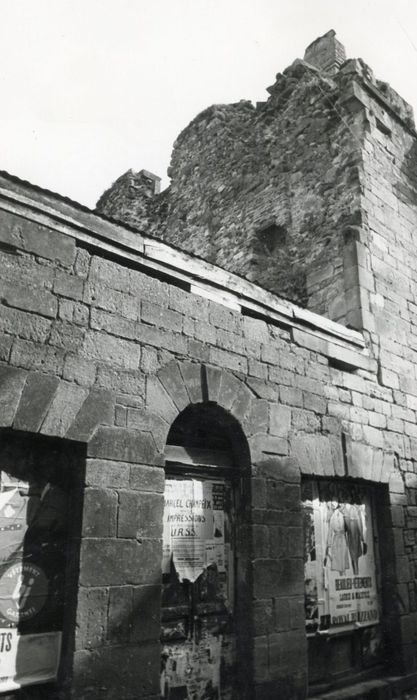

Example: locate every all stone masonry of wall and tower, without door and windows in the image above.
[0,33,417,700]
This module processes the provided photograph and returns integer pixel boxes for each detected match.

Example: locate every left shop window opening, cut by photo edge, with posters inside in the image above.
[0,432,80,697]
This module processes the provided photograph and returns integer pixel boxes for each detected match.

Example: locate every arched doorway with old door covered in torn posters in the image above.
[161,403,251,700]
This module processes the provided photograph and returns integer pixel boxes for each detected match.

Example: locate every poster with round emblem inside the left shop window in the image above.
[0,472,67,692]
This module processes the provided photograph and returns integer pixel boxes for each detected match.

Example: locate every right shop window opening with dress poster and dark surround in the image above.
[302,479,382,685]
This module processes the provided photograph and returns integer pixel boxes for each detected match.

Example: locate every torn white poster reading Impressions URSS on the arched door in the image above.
[162,479,226,583]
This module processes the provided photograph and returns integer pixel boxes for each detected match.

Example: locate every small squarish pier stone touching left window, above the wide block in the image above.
[82,488,117,537]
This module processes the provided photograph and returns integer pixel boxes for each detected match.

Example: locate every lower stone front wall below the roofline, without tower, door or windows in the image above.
[0,176,417,700]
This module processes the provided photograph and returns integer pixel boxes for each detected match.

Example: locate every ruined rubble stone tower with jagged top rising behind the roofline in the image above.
[98,31,415,342]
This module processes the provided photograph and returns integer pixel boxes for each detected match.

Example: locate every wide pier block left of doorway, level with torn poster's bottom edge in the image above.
[80,538,162,586]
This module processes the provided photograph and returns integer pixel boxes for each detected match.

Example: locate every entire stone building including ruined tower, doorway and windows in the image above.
[0,32,417,700]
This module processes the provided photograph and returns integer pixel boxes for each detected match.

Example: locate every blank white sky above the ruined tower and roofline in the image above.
[0,0,417,207]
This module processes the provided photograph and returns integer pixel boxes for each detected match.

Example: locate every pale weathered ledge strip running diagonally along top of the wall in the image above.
[0,173,370,372]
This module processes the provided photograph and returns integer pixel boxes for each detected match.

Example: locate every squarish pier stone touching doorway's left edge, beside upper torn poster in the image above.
[117,491,164,540]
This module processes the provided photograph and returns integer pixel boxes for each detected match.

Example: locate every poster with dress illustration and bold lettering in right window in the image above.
[302,480,379,633]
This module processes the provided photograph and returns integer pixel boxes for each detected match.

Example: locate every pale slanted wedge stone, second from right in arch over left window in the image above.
[41,381,87,437]
